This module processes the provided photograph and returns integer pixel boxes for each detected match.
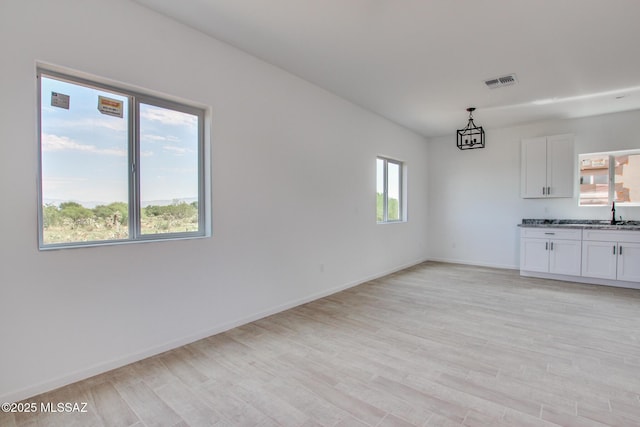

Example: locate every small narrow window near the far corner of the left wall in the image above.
[376,157,404,222]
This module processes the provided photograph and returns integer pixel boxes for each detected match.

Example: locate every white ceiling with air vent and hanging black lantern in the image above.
[135,0,640,137]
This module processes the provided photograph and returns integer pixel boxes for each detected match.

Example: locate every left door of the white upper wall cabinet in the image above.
[520,138,547,198]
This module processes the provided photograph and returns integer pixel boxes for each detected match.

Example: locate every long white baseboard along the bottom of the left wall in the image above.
[0,258,427,402]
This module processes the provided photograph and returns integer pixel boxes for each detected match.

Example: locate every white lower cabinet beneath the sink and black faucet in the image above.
[582,230,640,282]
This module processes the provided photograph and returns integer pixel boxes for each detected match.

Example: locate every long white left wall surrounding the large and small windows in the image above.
[0,0,428,401]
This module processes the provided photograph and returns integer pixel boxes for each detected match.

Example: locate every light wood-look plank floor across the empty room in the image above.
[0,262,640,427]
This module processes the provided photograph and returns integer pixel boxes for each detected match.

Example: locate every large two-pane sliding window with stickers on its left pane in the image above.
[38,70,205,248]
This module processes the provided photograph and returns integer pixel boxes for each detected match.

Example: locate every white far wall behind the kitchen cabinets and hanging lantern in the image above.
[428,111,640,268]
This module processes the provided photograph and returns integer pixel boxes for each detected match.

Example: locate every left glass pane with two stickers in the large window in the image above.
[40,76,129,244]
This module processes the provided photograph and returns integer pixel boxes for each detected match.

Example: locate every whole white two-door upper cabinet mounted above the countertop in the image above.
[521,135,575,198]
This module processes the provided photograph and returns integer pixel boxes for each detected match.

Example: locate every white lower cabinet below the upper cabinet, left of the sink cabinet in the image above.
[520,228,582,276]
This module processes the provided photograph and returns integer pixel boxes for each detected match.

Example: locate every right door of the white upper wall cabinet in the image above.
[546,135,577,197]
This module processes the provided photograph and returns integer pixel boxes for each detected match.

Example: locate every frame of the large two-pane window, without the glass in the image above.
[36,66,210,250]
